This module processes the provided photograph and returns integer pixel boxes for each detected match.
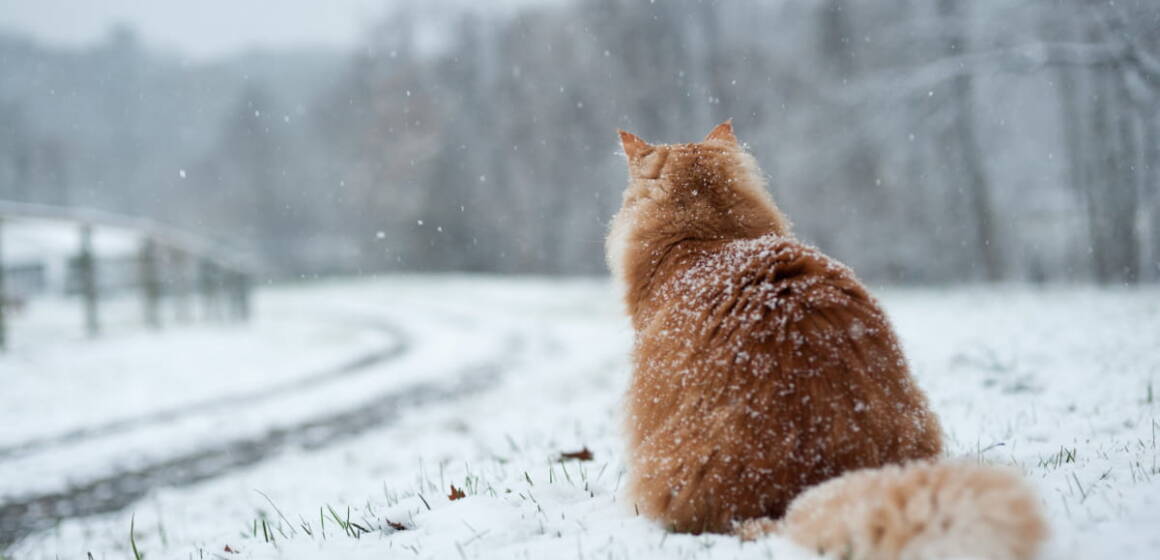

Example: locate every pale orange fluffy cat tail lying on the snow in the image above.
[735,461,1047,560]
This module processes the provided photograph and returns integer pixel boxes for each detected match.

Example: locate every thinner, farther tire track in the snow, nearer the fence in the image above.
[0,321,411,461]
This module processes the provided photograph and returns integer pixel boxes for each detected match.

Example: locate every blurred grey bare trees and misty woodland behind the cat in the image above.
[0,0,1160,283]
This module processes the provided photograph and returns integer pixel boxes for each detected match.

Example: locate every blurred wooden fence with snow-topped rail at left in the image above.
[0,201,258,350]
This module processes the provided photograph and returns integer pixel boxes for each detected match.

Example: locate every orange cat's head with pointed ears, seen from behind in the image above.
[606,121,789,287]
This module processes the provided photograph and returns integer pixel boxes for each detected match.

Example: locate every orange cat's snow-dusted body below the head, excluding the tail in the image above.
[628,235,941,531]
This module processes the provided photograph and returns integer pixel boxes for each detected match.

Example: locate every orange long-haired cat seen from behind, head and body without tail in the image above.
[607,122,1048,558]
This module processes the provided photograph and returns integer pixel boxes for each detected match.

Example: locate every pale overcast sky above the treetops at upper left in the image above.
[0,0,552,57]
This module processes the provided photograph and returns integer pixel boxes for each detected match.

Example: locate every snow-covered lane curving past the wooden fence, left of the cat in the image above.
[0,278,540,549]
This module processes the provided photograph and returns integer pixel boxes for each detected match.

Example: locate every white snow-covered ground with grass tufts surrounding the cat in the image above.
[0,277,1160,559]
